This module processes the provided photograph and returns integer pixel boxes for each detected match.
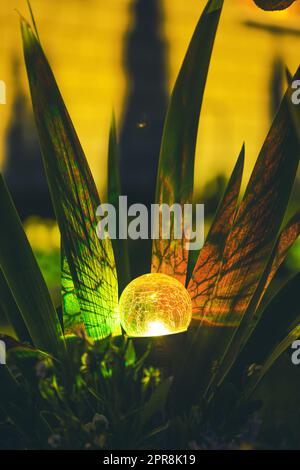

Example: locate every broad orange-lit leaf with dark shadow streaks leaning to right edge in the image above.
[206,71,300,326]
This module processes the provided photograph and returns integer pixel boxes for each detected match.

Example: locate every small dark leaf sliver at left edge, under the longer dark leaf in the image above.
[0,269,32,343]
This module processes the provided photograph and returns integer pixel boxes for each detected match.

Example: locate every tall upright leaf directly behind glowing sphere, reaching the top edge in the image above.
[151,0,223,284]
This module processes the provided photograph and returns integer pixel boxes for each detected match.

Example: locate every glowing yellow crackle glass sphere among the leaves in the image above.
[119,273,192,337]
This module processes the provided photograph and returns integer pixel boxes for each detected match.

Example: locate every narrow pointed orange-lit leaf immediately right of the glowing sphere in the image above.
[175,146,245,395]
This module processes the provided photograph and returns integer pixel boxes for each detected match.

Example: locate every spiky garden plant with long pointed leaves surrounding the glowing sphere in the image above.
[0,0,300,450]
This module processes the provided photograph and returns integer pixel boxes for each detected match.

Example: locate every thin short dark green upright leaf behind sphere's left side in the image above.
[107,114,130,294]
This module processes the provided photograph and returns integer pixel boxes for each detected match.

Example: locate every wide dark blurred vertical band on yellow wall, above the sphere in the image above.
[120,0,167,277]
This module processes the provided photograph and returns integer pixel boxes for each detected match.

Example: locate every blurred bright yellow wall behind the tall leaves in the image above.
[0,0,300,196]
